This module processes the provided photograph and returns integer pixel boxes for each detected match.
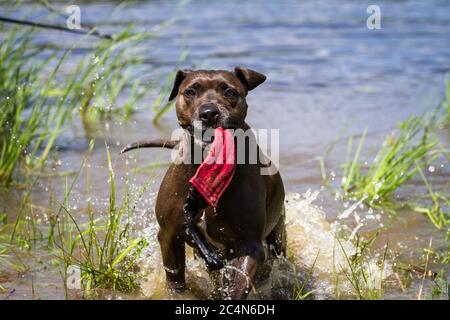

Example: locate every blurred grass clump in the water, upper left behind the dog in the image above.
[64,27,154,123]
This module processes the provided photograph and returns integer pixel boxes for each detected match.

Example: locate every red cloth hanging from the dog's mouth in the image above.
[189,127,236,207]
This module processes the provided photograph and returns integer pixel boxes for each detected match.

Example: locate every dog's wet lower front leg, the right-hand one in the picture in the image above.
[230,243,265,300]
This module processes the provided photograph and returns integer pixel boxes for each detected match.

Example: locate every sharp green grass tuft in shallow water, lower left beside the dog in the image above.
[57,141,147,297]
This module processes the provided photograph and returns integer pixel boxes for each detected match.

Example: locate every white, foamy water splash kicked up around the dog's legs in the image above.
[136,190,390,299]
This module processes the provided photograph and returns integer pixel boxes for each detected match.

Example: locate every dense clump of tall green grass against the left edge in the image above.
[0,29,51,185]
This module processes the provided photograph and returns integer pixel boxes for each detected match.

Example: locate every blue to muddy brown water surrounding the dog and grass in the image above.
[0,1,450,299]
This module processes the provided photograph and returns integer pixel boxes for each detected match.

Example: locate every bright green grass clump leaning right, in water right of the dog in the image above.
[342,117,440,214]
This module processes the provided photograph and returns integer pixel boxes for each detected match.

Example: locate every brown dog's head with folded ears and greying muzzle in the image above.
[169,67,266,141]
